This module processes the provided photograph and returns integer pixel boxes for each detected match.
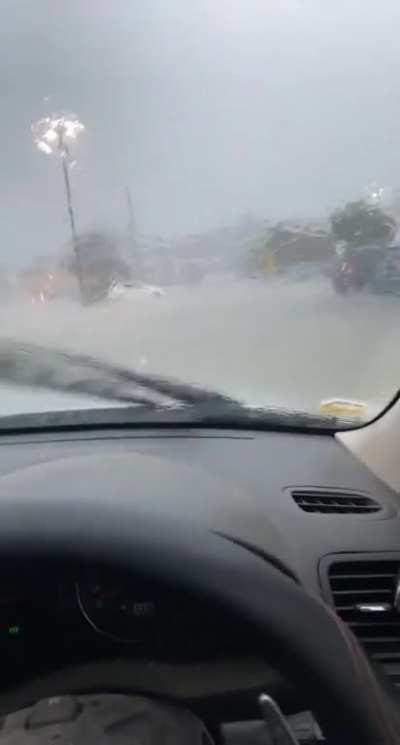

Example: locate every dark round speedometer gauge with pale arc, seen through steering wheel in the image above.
[76,568,156,643]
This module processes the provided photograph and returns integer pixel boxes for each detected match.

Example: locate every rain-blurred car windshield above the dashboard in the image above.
[0,0,400,421]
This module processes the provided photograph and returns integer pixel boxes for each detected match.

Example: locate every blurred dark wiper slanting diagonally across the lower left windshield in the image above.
[0,340,232,408]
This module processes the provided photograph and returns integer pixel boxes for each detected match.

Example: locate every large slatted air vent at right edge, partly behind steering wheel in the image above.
[328,557,400,690]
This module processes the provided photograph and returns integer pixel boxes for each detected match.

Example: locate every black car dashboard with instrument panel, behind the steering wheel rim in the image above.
[0,428,400,708]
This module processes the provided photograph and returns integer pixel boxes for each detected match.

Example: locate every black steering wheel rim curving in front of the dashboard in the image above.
[0,493,400,745]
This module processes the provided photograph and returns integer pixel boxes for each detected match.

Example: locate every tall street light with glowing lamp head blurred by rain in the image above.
[31,115,85,301]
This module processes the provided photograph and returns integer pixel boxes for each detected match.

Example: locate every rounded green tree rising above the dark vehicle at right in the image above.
[331,200,396,248]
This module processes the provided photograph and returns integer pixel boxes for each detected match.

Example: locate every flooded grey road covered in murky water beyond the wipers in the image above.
[0,280,400,422]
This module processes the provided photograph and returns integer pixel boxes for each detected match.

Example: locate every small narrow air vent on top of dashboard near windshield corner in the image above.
[292,489,382,515]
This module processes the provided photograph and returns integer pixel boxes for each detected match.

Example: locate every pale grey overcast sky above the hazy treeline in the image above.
[0,0,400,263]
